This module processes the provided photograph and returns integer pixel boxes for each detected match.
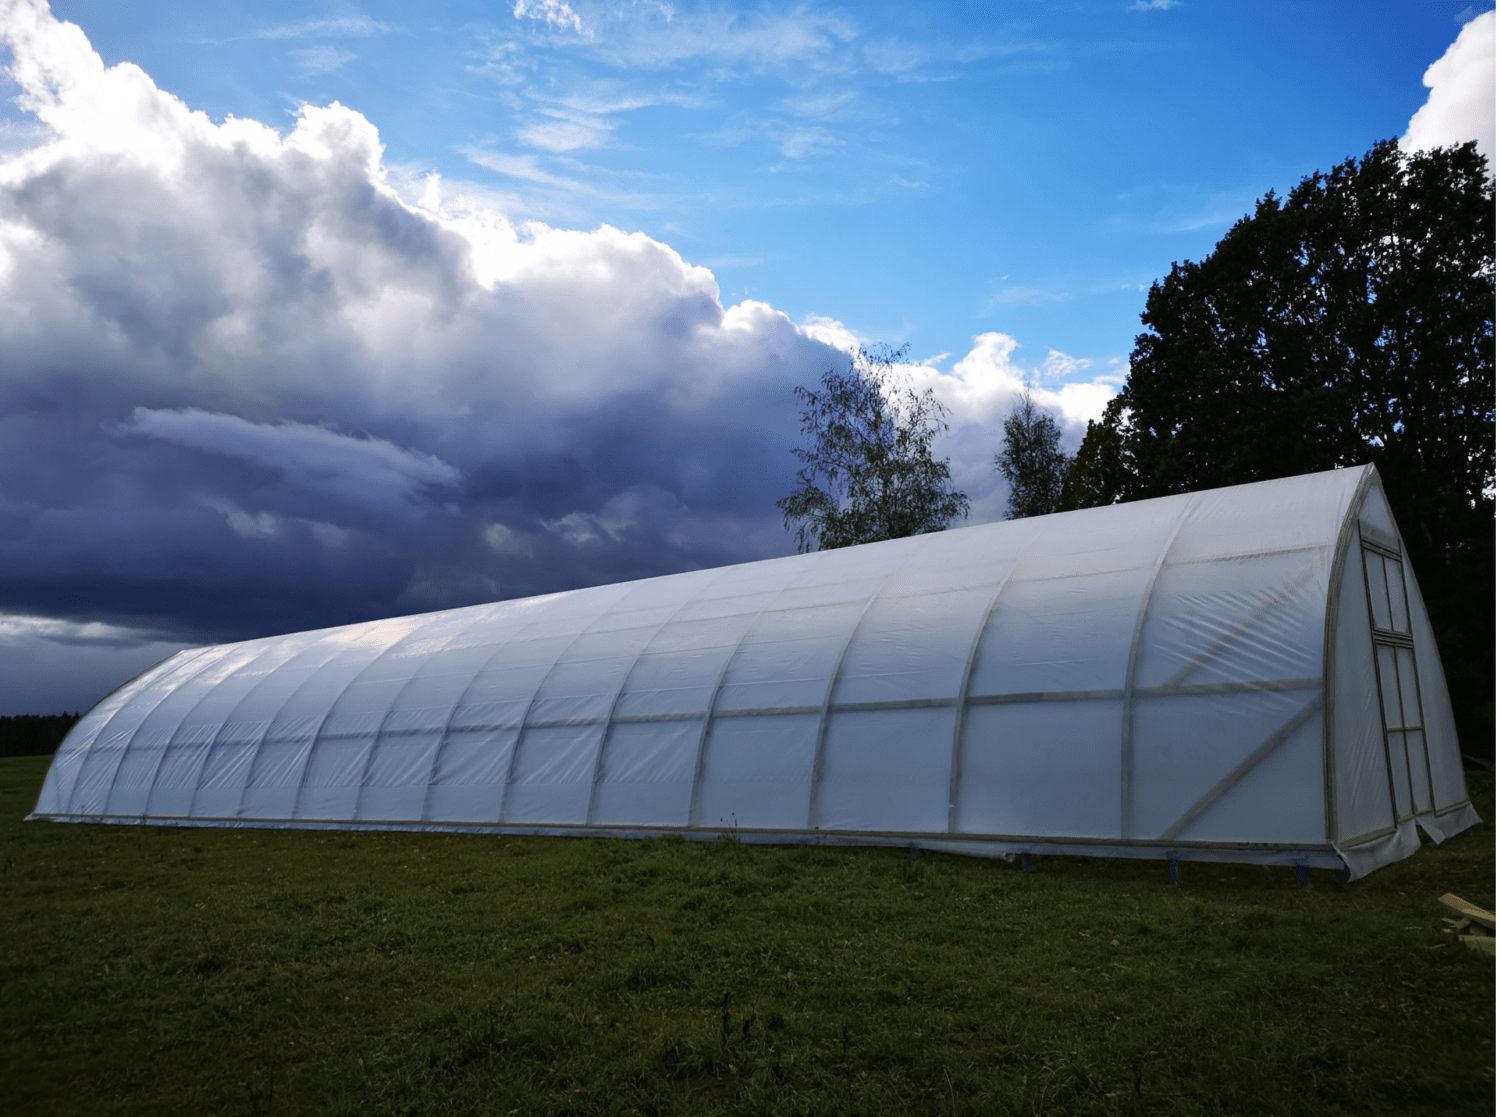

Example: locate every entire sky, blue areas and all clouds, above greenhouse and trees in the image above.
[0,0,1494,714]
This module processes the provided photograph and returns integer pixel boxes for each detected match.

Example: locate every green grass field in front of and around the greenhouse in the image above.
[0,759,1494,1116]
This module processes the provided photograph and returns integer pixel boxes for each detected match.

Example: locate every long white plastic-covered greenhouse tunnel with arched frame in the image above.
[33,468,1476,876]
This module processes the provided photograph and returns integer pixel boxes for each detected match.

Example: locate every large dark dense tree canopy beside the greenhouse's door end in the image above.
[1070,141,1496,753]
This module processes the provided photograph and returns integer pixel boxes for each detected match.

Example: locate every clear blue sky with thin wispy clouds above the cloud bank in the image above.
[41,0,1491,367]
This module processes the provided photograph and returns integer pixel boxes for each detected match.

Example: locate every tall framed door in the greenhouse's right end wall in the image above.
[1362,540,1434,822]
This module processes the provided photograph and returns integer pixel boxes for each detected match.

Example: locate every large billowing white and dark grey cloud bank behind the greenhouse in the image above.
[0,0,1112,712]
